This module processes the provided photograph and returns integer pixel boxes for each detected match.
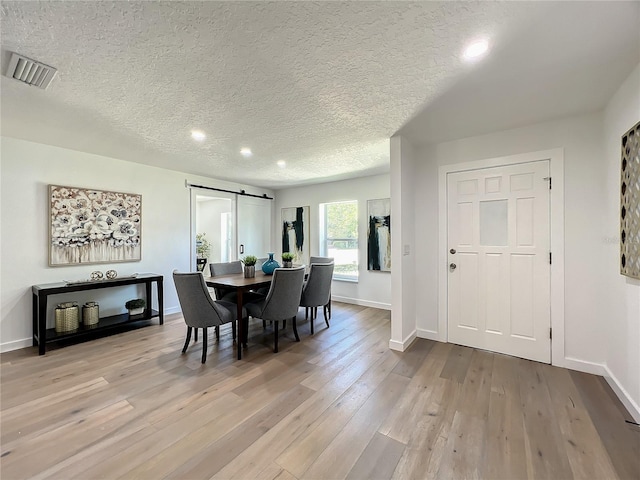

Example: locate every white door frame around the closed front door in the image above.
[438,148,565,365]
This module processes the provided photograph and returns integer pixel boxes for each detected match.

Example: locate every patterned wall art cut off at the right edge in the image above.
[620,122,640,279]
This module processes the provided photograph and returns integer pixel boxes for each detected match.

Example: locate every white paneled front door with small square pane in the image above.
[447,160,551,363]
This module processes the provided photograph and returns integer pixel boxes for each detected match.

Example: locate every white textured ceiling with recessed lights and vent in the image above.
[0,1,640,188]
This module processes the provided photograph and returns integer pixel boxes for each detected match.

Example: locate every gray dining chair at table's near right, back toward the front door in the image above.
[245,267,304,353]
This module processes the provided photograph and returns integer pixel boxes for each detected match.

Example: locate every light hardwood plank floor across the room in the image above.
[0,303,640,480]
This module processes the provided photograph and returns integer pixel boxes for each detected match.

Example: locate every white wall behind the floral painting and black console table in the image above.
[0,137,272,351]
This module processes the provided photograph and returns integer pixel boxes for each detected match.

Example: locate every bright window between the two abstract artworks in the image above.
[320,200,358,281]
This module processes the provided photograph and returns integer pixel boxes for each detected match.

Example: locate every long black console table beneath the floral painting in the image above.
[31,273,164,355]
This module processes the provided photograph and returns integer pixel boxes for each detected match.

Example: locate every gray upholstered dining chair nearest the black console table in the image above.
[173,270,246,363]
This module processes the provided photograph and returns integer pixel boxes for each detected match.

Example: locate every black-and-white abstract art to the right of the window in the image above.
[367,198,391,272]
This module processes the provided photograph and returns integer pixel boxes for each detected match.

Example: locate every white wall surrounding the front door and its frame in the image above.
[413,114,607,371]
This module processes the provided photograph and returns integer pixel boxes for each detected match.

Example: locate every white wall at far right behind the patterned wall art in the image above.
[599,64,640,421]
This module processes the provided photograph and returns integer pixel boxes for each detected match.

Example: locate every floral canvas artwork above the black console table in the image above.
[49,185,142,266]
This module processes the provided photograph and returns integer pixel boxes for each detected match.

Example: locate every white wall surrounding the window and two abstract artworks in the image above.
[272,175,393,309]
